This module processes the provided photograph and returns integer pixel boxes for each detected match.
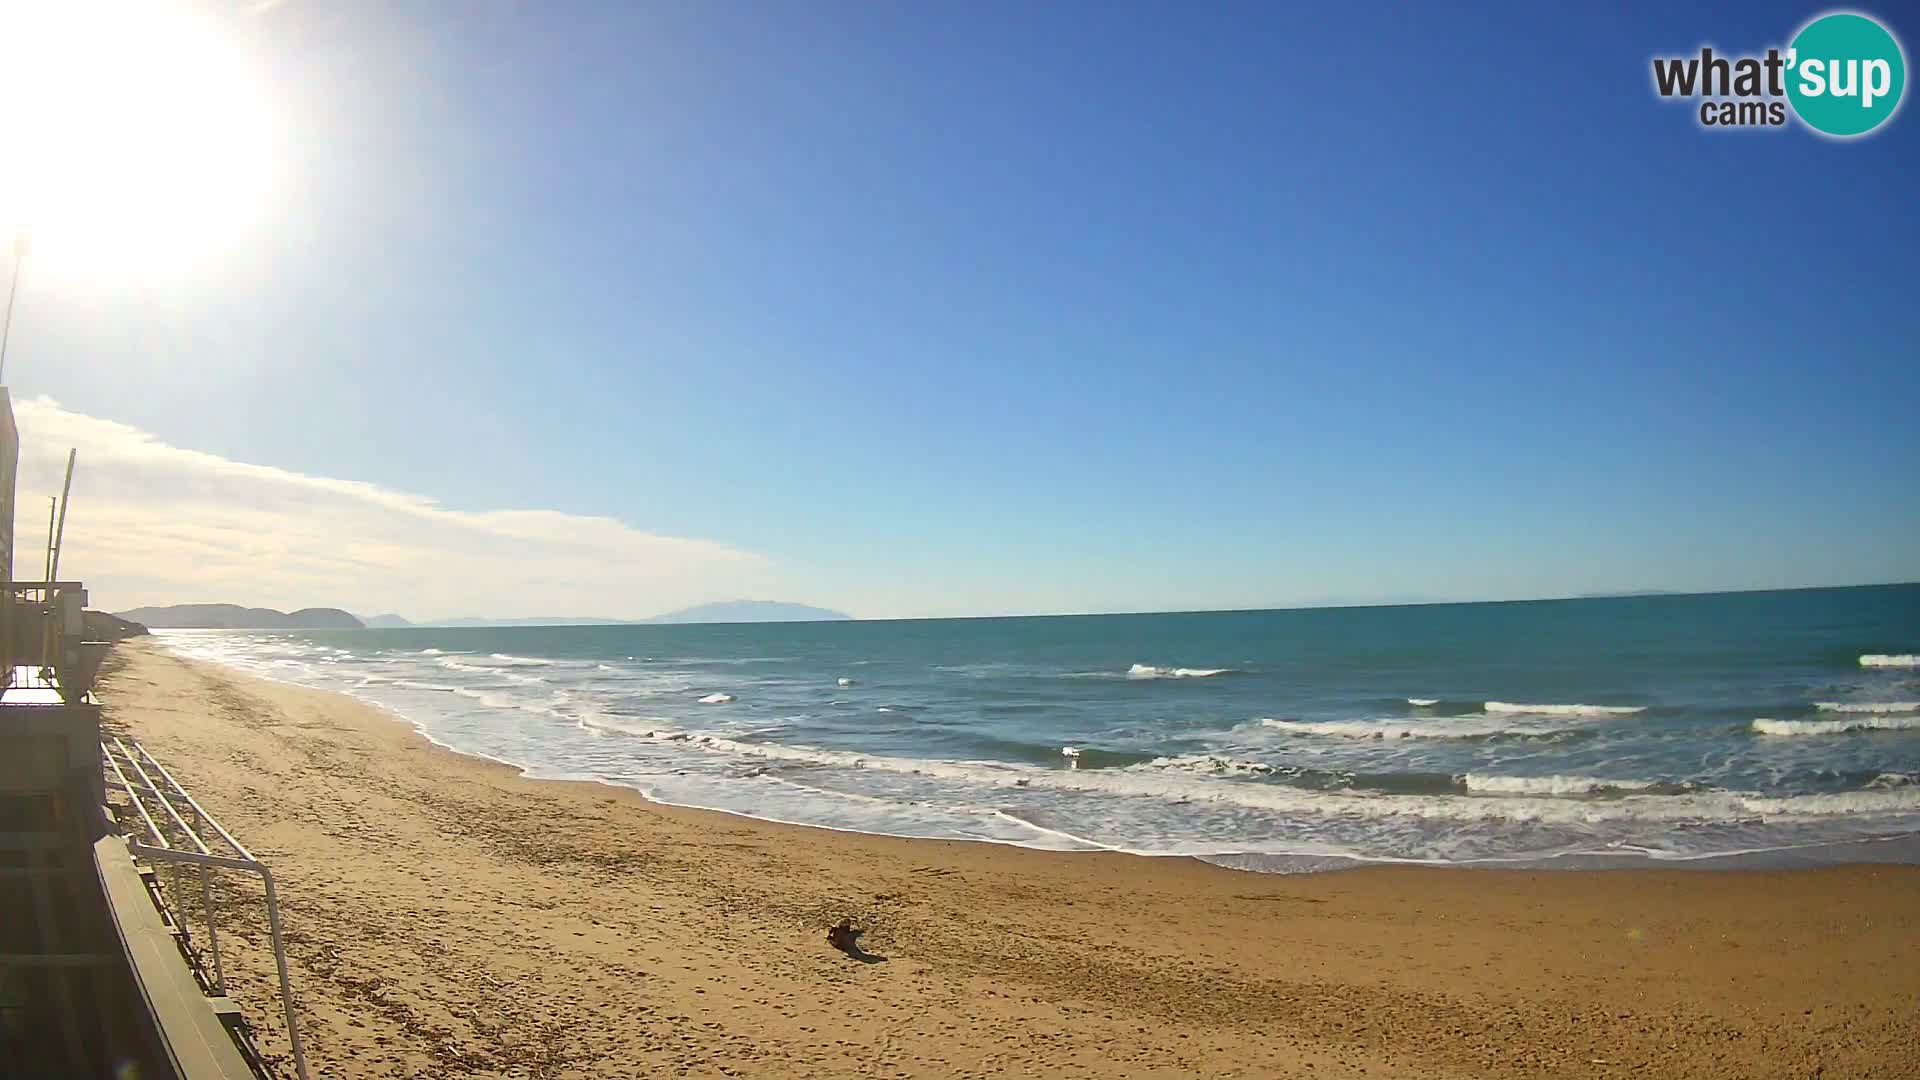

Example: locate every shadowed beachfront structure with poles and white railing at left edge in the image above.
[0,386,305,1080]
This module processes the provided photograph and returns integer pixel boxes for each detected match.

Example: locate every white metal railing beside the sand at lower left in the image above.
[100,736,307,1080]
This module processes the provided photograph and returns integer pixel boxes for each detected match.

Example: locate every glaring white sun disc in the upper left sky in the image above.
[0,0,280,282]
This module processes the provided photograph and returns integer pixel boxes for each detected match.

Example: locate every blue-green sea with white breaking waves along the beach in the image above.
[159,584,1920,872]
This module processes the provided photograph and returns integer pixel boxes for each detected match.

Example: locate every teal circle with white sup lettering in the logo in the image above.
[1788,12,1907,138]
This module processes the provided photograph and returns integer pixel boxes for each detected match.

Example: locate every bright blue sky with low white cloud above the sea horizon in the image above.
[0,0,1920,617]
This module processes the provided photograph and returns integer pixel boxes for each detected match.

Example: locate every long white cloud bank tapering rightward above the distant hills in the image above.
[13,398,768,617]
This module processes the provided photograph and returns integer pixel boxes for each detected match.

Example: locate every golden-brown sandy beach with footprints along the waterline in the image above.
[100,642,1920,1076]
